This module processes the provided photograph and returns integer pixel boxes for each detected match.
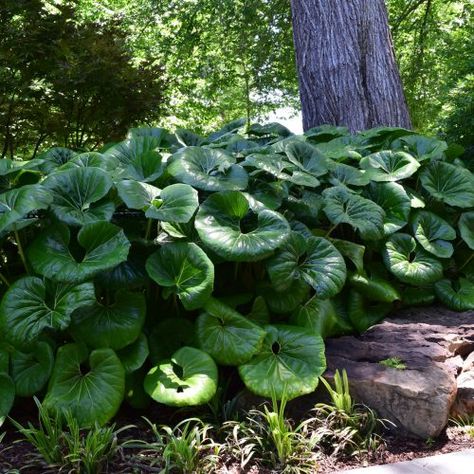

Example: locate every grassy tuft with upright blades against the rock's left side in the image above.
[313,370,390,457]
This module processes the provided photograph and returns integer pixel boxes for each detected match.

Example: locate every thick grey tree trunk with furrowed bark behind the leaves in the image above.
[291,0,411,132]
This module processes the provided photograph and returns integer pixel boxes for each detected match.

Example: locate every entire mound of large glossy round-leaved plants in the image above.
[0,121,474,427]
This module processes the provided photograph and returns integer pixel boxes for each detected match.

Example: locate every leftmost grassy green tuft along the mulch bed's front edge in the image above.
[12,400,130,474]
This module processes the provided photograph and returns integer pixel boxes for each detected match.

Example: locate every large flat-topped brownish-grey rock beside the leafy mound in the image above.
[326,307,474,438]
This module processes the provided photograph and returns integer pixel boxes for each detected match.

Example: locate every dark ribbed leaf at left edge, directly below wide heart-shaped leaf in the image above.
[0,276,94,346]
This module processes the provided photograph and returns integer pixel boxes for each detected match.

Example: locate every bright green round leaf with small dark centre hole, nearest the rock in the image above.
[239,325,326,400]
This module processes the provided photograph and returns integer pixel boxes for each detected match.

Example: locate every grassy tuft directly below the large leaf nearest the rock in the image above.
[224,390,316,473]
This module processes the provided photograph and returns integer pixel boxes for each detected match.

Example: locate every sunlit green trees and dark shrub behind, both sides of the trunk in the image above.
[0,0,474,158]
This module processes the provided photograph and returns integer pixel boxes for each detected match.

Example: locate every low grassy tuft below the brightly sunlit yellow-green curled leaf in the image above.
[126,418,220,474]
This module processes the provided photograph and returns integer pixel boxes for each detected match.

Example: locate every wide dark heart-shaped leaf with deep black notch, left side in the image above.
[27,222,130,282]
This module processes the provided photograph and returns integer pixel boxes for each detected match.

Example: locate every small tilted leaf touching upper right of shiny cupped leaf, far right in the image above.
[410,211,456,258]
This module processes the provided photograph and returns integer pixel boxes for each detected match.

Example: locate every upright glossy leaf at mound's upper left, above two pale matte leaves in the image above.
[104,136,165,183]
